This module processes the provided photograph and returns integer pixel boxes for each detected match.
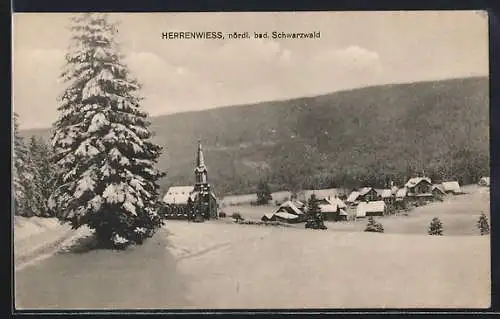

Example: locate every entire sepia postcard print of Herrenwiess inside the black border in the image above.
[11,10,491,311]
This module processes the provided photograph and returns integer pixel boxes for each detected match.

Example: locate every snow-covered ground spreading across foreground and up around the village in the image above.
[14,188,490,309]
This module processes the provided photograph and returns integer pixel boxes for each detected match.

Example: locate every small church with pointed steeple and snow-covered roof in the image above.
[163,141,218,221]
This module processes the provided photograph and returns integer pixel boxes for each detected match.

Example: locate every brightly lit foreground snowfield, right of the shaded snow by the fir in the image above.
[167,221,490,308]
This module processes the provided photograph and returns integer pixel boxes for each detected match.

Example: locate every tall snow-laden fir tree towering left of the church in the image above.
[49,13,164,247]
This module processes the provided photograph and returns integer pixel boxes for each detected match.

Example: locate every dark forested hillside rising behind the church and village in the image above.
[23,77,489,198]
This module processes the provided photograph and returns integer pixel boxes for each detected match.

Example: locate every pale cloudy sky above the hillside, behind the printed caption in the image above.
[13,11,488,128]
